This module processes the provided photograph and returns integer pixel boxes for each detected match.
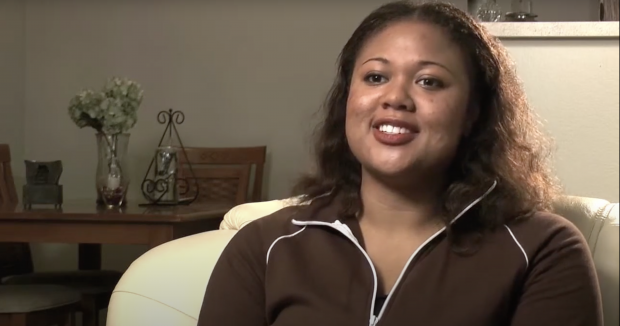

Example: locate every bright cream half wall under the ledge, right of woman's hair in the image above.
[505,38,619,202]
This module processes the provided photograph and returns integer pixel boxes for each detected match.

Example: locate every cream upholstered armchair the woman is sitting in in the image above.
[107,197,619,326]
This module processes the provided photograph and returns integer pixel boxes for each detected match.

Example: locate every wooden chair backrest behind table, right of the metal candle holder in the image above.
[179,146,267,205]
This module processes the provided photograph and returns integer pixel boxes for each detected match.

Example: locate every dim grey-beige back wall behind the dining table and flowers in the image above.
[25,0,394,270]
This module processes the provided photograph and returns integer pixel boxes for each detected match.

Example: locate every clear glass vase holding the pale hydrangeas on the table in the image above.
[96,133,130,207]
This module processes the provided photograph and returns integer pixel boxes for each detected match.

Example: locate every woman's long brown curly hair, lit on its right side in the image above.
[293,1,560,233]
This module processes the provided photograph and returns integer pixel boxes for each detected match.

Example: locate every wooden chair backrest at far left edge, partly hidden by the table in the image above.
[0,144,34,280]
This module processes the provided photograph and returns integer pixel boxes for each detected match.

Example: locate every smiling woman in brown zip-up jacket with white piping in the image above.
[198,2,602,326]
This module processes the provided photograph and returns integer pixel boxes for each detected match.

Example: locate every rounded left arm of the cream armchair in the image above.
[106,230,237,326]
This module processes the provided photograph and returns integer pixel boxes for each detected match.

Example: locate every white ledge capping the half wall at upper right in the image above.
[483,22,620,39]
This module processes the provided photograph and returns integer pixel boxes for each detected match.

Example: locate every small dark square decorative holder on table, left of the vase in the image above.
[23,160,63,209]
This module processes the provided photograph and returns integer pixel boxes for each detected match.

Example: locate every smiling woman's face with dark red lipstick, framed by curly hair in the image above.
[346,22,473,180]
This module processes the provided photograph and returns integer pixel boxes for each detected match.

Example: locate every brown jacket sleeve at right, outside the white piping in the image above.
[506,212,602,325]
